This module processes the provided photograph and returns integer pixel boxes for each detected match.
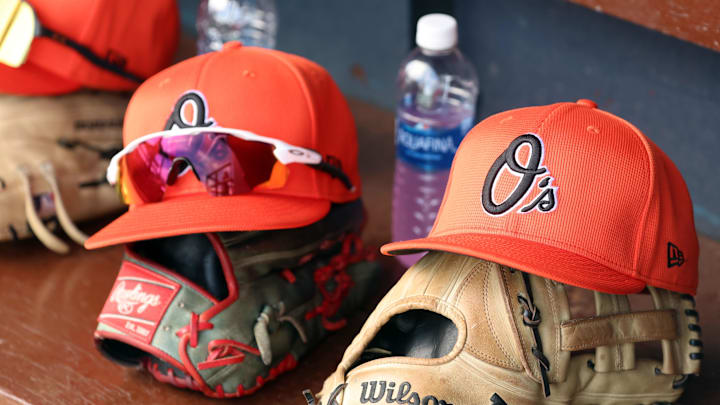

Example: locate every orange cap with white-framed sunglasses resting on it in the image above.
[85,42,361,249]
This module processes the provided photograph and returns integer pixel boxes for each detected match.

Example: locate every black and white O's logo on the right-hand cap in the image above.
[482,134,557,216]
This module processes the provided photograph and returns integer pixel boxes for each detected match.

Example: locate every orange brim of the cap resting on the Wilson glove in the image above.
[380,233,645,294]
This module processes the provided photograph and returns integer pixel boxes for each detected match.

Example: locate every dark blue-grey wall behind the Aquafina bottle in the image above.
[179,0,720,240]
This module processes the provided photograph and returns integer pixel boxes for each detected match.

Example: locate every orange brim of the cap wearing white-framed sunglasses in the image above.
[85,194,330,249]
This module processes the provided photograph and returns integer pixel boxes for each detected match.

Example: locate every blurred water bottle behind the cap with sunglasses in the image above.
[197,0,277,54]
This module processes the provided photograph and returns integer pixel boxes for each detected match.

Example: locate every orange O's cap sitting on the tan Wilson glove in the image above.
[382,100,698,294]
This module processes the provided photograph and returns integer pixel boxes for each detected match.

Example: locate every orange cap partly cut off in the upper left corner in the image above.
[0,0,180,95]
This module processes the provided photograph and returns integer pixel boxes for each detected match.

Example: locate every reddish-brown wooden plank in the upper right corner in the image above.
[569,0,720,51]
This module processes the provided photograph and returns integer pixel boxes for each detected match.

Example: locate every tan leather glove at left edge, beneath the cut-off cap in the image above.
[0,91,128,253]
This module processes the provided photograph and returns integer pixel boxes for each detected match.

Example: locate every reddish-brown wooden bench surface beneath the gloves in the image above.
[0,101,720,405]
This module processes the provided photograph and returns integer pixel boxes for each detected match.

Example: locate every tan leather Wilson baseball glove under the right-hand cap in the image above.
[304,252,702,405]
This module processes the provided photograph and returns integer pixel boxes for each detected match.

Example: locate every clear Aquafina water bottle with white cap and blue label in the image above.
[392,14,478,266]
